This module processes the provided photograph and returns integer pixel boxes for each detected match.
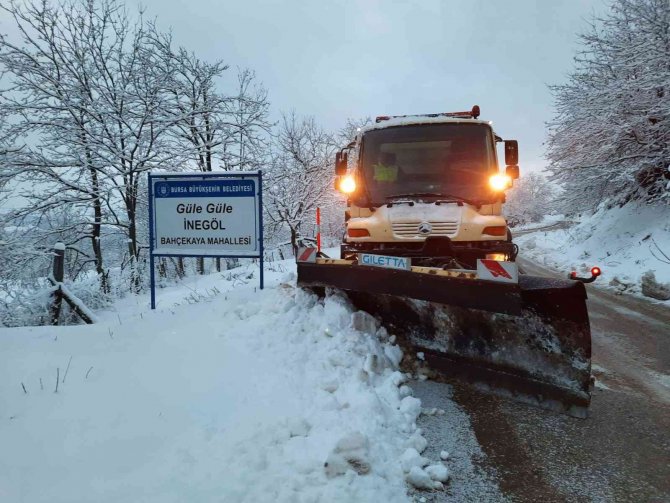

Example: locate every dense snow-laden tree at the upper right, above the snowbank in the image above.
[548,0,670,210]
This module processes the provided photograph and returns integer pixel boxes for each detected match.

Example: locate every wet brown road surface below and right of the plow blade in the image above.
[430,260,670,502]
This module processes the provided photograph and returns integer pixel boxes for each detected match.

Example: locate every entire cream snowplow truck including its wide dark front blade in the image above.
[297,106,594,417]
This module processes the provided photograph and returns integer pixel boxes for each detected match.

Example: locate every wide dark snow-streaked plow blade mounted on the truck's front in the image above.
[298,260,591,417]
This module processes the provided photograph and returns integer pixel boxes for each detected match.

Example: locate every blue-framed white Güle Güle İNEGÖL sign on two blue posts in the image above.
[149,171,263,309]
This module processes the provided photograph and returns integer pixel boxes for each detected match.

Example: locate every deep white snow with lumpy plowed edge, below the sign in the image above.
[0,262,456,503]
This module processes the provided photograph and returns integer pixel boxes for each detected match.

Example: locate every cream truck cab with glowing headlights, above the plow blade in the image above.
[336,106,519,268]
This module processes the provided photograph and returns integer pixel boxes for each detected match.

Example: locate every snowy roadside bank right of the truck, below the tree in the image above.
[513,205,670,303]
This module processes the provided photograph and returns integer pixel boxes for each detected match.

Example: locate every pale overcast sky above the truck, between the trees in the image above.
[134,0,607,173]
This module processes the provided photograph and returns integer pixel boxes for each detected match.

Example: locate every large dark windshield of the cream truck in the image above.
[361,123,497,203]
